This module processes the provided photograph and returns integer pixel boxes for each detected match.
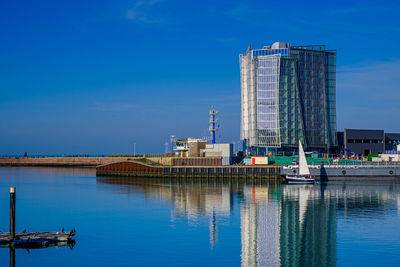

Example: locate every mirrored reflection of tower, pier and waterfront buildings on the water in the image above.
[97,177,400,266]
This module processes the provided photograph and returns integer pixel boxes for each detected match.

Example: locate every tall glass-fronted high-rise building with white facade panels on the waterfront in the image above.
[239,42,337,153]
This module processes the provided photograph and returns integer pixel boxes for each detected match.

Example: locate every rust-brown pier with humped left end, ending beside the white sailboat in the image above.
[96,161,280,179]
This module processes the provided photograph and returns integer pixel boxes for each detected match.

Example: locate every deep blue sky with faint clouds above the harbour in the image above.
[0,0,400,155]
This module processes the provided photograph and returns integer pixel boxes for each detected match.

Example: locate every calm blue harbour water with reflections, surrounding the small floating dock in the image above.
[0,168,400,266]
